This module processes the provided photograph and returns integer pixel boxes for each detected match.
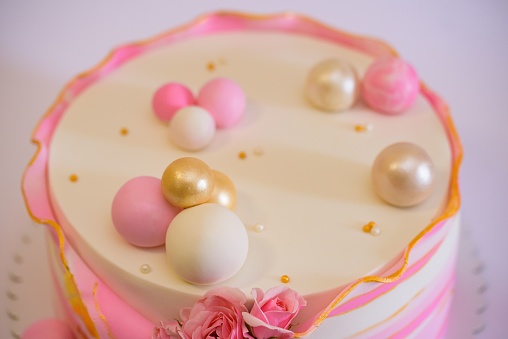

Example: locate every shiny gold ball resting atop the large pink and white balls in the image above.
[161,157,214,208]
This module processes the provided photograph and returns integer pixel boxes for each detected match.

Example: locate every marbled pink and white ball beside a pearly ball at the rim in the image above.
[362,57,420,115]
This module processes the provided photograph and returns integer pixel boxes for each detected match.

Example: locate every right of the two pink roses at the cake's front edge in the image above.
[243,286,307,339]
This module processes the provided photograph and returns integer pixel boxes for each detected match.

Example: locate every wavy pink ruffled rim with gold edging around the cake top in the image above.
[22,13,462,337]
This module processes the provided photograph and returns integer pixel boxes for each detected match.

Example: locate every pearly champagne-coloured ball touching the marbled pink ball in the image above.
[305,59,360,112]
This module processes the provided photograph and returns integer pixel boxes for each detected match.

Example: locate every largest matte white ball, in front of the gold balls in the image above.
[166,203,249,285]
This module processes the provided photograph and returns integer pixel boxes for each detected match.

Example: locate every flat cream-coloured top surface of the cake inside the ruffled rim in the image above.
[48,30,452,296]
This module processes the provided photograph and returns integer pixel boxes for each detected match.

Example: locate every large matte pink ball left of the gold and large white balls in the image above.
[111,176,181,247]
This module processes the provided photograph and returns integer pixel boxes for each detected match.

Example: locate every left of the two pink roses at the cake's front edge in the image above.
[179,287,247,339]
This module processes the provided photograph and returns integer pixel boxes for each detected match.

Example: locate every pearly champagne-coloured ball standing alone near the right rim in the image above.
[372,142,434,207]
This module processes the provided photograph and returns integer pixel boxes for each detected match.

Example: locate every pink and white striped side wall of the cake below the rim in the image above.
[41,218,459,338]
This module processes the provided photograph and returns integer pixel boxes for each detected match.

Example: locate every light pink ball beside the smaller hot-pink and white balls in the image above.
[197,78,246,128]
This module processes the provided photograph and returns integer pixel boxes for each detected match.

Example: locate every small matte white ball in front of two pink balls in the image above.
[169,106,216,151]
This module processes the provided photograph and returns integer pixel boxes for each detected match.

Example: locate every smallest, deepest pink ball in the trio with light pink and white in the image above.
[152,82,194,121]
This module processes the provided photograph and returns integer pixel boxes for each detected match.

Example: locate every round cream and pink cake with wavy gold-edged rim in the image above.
[23,12,462,339]
